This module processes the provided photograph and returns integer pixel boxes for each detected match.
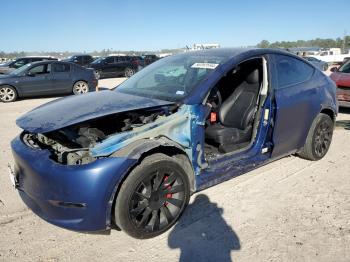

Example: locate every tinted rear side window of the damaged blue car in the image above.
[275,55,314,89]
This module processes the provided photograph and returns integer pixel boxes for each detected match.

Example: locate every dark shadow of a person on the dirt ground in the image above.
[168,194,241,262]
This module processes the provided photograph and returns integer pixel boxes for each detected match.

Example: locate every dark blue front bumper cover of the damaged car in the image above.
[11,137,135,231]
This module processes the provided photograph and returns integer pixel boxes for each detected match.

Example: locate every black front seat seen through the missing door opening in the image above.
[205,69,260,152]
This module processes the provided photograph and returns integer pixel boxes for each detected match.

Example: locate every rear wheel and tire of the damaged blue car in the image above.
[298,113,334,161]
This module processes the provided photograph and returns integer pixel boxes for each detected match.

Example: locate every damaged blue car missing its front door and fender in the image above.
[10,49,337,238]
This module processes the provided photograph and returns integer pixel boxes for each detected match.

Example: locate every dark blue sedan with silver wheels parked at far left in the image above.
[0,61,97,102]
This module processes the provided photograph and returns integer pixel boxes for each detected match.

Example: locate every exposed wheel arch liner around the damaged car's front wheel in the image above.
[106,137,196,229]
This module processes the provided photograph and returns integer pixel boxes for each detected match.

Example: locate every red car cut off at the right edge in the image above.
[330,59,350,107]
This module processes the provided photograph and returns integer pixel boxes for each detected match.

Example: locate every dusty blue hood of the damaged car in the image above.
[16,90,173,133]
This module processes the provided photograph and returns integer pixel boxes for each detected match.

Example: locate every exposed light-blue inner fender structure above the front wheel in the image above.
[90,105,207,173]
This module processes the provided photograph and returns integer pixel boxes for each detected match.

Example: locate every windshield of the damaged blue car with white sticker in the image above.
[116,52,228,102]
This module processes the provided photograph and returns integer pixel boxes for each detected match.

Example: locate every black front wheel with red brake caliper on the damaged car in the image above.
[114,153,190,239]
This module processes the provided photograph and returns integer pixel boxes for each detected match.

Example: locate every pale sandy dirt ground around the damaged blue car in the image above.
[0,79,350,262]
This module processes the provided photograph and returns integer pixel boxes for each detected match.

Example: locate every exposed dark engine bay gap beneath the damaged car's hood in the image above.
[22,106,178,165]
